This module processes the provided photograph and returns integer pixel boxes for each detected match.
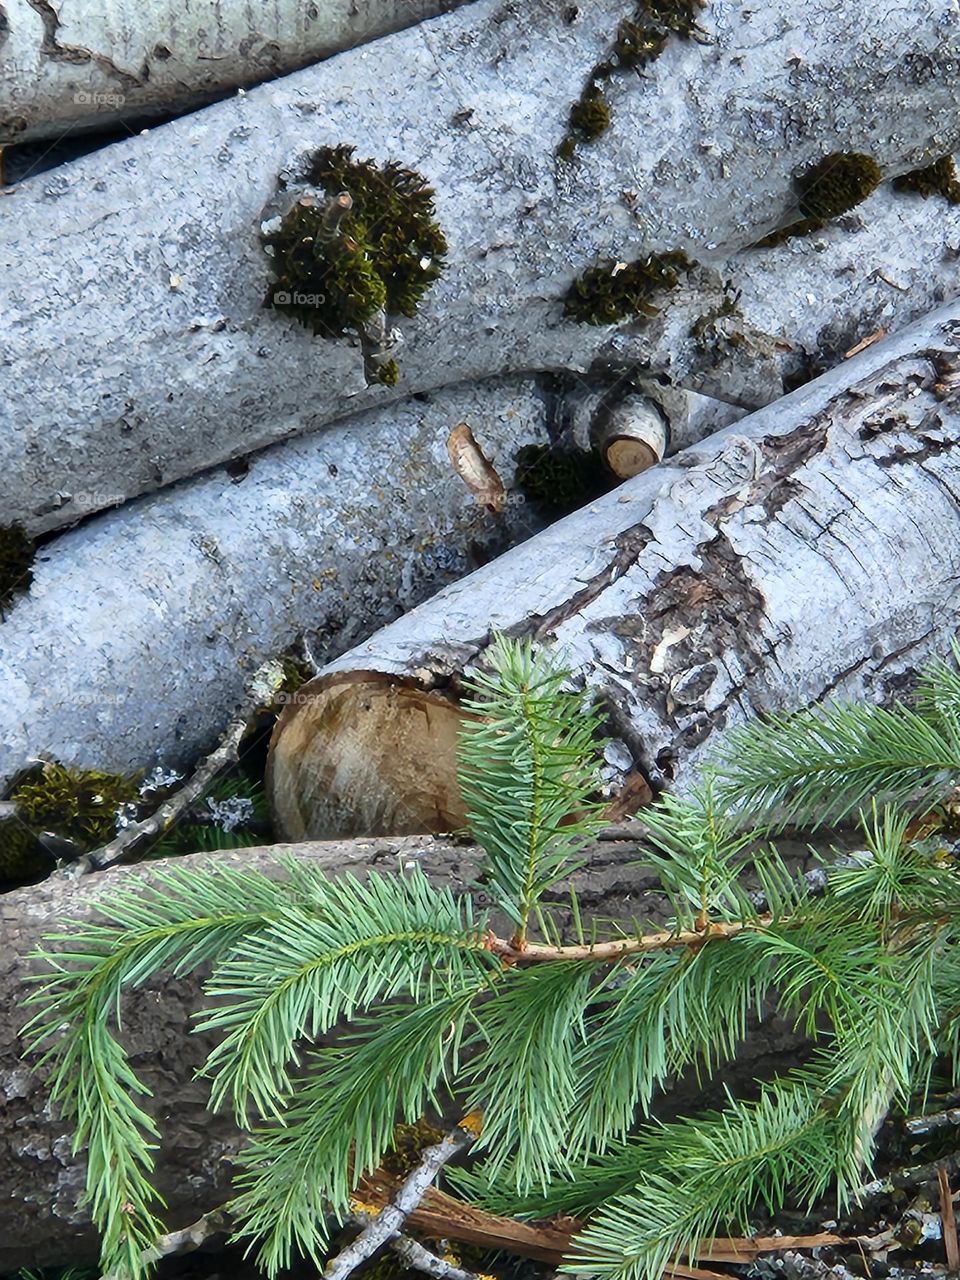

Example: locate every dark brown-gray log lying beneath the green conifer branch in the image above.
[0,837,804,1271]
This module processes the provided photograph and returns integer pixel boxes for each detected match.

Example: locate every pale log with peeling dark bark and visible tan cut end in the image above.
[268,302,960,838]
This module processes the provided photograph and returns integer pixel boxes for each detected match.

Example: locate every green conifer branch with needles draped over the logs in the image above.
[20,637,960,1280]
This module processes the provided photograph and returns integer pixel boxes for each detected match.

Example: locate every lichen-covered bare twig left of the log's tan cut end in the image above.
[74,660,293,876]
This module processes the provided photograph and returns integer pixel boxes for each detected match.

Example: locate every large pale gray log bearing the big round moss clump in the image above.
[0,0,960,529]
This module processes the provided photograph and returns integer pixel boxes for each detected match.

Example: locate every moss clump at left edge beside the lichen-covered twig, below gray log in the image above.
[10,762,140,851]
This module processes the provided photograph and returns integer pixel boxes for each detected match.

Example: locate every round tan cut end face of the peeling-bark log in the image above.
[268,671,466,840]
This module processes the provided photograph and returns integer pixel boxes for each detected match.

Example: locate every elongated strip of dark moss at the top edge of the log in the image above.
[557,0,705,160]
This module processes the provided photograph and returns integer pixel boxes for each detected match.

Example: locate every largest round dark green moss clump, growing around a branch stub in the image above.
[264,146,447,380]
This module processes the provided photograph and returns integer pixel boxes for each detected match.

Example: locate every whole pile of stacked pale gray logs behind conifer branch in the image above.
[0,0,960,1275]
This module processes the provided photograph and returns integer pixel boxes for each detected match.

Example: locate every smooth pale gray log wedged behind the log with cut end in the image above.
[0,380,549,781]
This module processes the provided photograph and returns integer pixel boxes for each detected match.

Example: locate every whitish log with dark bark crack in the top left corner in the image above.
[0,0,465,145]
